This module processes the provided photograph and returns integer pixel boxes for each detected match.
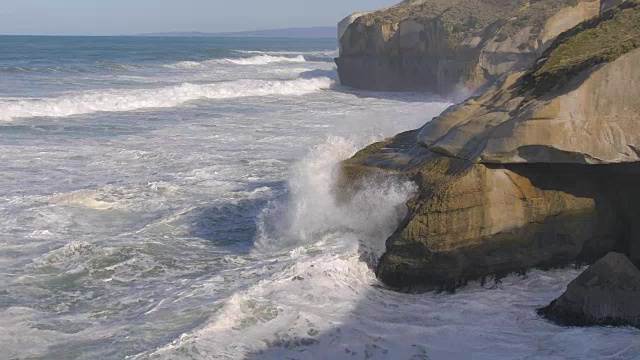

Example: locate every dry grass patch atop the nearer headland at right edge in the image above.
[523,0,640,97]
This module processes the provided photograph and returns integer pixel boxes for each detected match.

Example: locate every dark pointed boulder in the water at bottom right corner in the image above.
[538,253,640,327]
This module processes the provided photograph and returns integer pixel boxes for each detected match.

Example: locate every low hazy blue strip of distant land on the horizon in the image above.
[135,26,338,39]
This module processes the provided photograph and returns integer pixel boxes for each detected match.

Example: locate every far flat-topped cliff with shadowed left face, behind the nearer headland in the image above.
[336,0,601,95]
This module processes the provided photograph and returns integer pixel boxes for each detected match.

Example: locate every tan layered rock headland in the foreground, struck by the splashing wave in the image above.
[339,1,640,290]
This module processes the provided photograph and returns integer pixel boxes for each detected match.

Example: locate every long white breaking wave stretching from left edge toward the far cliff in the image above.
[0,77,333,121]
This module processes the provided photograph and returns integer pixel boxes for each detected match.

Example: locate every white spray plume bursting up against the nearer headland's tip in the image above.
[256,137,416,261]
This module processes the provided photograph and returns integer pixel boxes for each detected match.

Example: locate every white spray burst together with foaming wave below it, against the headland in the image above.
[140,137,415,359]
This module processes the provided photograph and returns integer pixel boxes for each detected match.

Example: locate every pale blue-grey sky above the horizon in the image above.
[0,0,399,35]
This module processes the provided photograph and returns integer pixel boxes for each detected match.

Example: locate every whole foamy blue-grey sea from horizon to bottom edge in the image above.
[0,36,640,360]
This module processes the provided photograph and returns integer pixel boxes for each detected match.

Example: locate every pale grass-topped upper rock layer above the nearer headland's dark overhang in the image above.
[418,2,640,164]
